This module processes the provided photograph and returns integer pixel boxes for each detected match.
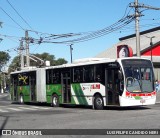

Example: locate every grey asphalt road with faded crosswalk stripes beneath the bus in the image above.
[0,94,160,138]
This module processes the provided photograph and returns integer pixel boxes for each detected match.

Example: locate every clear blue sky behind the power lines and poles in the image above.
[0,0,160,63]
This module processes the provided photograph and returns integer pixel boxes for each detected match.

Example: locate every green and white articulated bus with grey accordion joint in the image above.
[11,57,156,109]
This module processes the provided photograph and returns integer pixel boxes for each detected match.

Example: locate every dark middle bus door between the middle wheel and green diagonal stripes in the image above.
[61,71,71,103]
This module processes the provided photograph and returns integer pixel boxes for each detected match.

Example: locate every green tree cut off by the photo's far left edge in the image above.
[0,51,10,70]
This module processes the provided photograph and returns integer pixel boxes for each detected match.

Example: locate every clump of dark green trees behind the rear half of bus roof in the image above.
[9,52,67,72]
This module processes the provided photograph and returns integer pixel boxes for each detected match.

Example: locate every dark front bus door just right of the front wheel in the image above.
[105,68,120,105]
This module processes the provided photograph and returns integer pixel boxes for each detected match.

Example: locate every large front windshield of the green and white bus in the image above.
[122,59,154,92]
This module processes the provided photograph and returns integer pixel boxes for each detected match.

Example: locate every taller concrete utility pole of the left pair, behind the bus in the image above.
[25,30,30,67]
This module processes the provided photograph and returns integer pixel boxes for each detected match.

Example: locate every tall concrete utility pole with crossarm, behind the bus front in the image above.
[130,0,160,57]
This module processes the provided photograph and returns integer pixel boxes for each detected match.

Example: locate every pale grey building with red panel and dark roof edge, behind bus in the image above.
[96,27,160,80]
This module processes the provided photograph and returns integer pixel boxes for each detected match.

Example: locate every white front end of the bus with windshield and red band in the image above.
[118,58,156,106]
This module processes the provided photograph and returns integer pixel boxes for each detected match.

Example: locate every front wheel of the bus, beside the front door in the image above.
[93,95,104,110]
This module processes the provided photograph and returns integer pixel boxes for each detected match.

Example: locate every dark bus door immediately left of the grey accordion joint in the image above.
[29,72,36,102]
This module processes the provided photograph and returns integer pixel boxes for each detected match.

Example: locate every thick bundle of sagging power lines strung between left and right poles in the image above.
[32,4,134,44]
